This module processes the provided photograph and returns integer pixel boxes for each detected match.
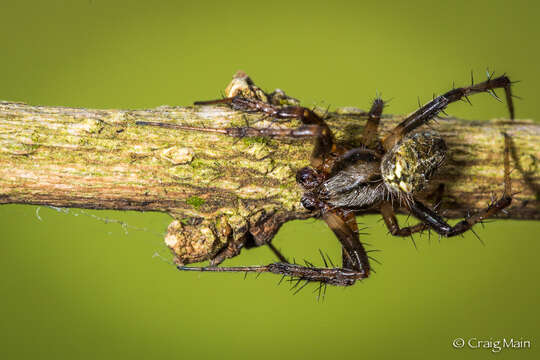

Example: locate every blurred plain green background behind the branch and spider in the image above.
[0,0,540,359]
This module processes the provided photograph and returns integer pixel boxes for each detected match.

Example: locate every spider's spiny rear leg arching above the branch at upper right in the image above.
[383,73,514,151]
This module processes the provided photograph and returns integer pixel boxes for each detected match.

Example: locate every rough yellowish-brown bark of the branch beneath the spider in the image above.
[0,74,540,263]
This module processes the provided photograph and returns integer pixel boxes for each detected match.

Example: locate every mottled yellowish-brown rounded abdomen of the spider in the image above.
[381,132,446,194]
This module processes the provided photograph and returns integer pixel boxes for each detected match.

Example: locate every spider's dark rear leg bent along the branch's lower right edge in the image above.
[408,133,512,237]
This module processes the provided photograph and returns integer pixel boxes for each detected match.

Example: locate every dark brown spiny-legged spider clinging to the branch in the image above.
[139,72,514,289]
